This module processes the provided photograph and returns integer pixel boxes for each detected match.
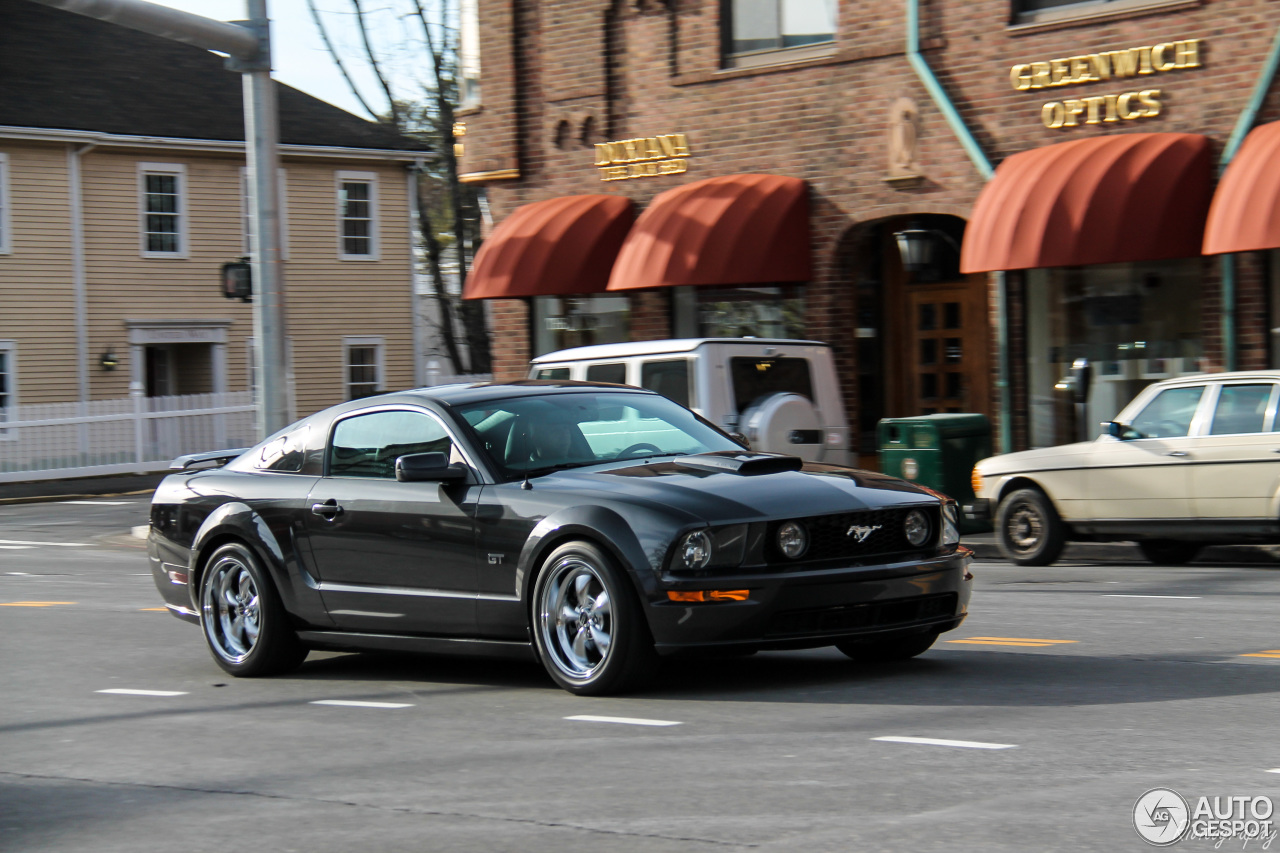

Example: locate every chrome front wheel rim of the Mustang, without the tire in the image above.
[538,555,613,681]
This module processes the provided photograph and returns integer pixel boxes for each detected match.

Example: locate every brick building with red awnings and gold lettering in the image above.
[458,0,1280,462]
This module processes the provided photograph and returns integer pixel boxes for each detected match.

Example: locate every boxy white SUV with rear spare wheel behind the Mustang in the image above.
[529,338,855,465]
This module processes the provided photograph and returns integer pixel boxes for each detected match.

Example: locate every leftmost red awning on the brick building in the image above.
[462,196,635,300]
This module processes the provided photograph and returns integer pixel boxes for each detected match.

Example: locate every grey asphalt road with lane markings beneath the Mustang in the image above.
[0,497,1280,853]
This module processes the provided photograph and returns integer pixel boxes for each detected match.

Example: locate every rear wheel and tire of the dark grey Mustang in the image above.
[200,542,307,678]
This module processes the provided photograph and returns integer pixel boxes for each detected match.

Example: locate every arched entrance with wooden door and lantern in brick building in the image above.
[845,214,991,465]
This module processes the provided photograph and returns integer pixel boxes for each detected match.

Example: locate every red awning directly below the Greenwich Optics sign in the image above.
[960,133,1212,273]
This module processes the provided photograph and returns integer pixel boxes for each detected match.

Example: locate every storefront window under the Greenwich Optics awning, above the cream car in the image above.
[1027,259,1204,447]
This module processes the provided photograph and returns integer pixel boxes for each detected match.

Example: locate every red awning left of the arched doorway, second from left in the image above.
[609,174,813,291]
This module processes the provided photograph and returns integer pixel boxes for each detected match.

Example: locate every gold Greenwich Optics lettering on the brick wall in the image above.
[1009,38,1204,129]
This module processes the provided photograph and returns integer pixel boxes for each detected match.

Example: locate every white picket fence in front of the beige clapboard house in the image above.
[0,391,256,483]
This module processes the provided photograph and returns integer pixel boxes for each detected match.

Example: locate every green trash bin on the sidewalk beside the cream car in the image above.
[877,414,991,533]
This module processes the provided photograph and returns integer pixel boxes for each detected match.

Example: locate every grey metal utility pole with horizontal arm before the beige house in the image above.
[33,0,292,438]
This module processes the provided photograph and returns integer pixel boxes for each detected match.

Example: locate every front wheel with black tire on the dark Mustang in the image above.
[532,542,658,695]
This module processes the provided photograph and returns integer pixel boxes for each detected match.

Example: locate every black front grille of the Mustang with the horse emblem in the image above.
[767,507,938,565]
